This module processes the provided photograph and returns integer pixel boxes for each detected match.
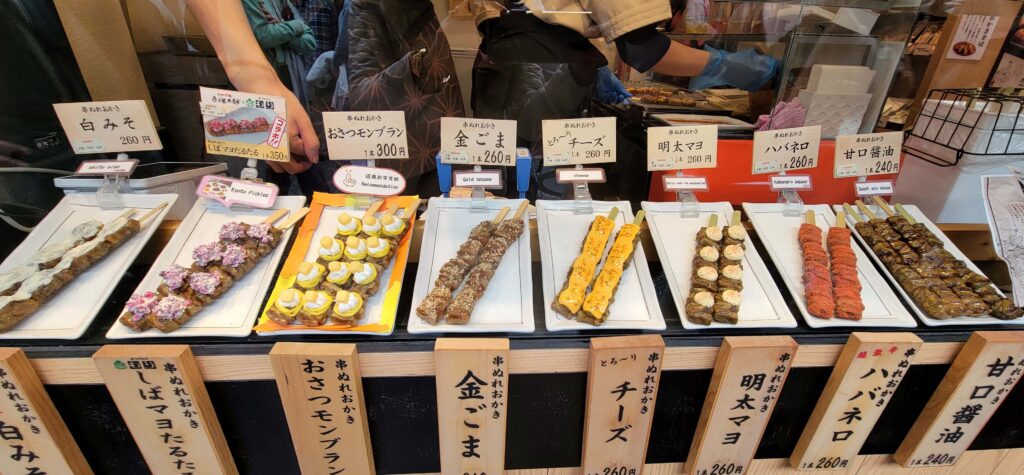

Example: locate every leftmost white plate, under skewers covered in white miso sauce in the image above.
[0,193,178,340]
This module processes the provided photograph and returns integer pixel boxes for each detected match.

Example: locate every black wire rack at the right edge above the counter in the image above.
[903,89,1024,167]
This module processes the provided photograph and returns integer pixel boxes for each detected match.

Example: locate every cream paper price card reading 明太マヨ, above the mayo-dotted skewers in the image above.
[647,125,718,172]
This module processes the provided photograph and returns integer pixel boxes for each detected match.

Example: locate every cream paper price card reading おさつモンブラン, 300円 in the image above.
[324,111,409,160]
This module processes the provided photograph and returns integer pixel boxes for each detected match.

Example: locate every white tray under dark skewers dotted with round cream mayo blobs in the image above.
[642,202,797,330]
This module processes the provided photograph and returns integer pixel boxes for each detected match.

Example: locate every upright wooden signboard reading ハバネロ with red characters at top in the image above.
[790,332,922,470]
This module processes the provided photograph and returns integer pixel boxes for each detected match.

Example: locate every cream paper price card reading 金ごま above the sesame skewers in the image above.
[441,117,516,167]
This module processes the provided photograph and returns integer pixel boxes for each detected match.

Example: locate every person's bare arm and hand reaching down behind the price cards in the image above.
[186,0,319,170]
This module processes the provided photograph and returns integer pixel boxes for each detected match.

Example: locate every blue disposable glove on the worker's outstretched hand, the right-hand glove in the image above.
[690,45,779,91]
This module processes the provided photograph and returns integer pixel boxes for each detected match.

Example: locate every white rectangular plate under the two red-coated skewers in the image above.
[743,203,918,329]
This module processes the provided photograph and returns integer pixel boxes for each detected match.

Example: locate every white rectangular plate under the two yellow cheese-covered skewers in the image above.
[537,200,665,332]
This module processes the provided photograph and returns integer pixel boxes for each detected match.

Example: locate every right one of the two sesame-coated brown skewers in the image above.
[444,200,529,325]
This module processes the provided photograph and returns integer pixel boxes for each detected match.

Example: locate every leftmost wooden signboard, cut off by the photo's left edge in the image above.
[0,348,92,474]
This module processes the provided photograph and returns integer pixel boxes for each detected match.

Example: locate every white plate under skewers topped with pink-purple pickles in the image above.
[106,197,306,340]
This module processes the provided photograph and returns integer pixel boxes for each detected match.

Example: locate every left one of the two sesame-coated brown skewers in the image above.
[416,207,509,325]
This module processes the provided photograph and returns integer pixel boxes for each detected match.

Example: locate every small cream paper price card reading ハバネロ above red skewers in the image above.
[753,125,821,175]
